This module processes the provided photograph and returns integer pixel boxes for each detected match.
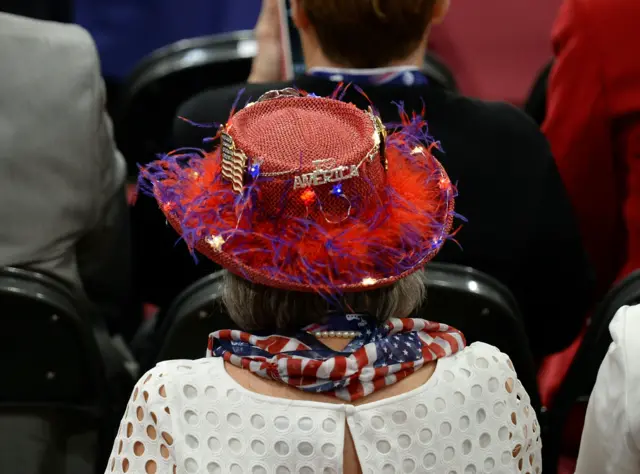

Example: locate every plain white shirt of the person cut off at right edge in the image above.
[576,306,640,474]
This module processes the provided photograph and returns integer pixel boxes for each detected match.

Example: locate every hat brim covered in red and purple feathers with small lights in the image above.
[143,148,455,293]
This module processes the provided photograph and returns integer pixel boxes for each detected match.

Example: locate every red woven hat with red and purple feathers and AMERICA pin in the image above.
[141,89,455,293]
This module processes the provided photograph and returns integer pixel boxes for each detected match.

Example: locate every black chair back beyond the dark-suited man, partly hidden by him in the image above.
[115,30,456,176]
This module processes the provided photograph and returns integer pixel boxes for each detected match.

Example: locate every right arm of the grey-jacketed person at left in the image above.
[76,38,136,337]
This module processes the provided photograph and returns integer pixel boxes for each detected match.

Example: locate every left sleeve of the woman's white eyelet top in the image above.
[105,367,176,474]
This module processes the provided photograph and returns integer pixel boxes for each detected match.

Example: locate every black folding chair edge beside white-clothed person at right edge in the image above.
[543,270,640,474]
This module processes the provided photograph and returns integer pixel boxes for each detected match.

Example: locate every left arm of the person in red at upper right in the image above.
[542,0,620,289]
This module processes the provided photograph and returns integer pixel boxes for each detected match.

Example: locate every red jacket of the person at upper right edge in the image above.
[543,0,640,294]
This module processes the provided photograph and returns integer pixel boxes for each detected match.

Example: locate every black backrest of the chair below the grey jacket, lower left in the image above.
[0,267,103,409]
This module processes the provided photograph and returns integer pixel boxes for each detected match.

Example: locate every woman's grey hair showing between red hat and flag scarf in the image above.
[222,270,426,331]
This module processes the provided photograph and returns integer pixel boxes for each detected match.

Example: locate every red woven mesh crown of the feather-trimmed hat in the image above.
[228,97,385,221]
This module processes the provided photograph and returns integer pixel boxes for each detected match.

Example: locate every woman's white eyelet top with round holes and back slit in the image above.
[106,343,542,474]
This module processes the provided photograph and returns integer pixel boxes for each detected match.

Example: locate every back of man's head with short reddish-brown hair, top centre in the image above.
[299,0,436,68]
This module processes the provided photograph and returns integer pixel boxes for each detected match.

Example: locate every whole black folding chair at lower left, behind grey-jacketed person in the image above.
[0,268,130,472]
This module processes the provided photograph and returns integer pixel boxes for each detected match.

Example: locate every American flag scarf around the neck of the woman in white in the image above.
[207,315,465,401]
